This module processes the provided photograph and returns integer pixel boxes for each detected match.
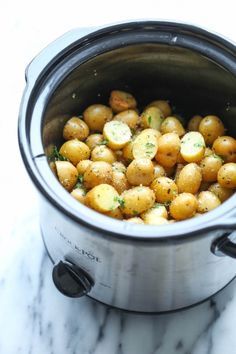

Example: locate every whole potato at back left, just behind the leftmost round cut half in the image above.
[83,104,113,132]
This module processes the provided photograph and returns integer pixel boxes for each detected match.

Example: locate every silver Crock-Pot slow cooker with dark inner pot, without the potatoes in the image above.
[19,21,236,312]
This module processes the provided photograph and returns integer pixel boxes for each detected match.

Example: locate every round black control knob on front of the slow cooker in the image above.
[52,261,94,298]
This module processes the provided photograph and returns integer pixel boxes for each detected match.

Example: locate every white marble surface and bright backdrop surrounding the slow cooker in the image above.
[0,0,236,354]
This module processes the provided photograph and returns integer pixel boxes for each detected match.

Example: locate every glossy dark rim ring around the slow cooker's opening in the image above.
[18,21,236,240]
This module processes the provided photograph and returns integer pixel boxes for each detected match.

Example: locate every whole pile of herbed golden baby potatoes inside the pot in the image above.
[53,90,236,225]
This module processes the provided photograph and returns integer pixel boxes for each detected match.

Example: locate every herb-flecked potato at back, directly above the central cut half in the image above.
[141,107,164,130]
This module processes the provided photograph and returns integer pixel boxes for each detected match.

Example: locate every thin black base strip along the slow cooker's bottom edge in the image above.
[41,231,236,315]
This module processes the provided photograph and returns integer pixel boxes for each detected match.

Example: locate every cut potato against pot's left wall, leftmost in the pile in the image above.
[55,161,78,191]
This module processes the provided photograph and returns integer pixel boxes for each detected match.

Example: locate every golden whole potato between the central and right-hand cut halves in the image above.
[155,133,180,167]
